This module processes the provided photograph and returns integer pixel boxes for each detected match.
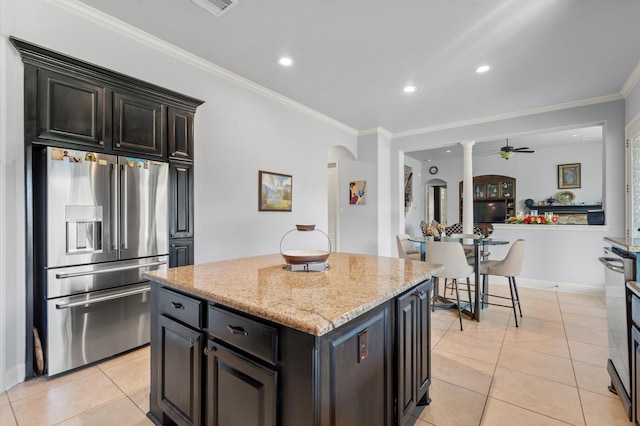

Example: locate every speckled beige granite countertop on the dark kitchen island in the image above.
[144,253,441,336]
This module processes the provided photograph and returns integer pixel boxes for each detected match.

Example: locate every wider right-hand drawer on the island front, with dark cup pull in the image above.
[208,305,278,365]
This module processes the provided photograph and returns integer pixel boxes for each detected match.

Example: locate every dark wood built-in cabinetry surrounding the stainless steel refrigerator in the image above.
[10,37,202,377]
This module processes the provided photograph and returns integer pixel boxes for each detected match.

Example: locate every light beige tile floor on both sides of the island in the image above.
[0,284,630,426]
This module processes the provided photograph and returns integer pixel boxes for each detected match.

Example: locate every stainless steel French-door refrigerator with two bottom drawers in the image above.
[36,147,169,375]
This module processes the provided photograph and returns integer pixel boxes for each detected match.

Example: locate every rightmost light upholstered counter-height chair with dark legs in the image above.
[479,239,525,327]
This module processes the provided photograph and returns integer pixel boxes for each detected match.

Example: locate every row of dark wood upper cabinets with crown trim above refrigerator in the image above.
[10,37,202,161]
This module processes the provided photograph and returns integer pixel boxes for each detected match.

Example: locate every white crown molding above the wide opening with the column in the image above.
[392,93,624,139]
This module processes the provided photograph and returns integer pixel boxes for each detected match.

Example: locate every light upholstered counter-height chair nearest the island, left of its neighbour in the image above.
[426,241,473,330]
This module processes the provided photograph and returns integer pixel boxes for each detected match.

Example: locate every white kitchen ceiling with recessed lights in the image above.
[77,0,640,134]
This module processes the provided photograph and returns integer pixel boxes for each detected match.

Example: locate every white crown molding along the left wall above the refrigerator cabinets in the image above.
[47,0,358,135]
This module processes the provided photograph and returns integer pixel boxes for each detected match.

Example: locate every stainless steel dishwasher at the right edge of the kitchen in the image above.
[599,247,635,419]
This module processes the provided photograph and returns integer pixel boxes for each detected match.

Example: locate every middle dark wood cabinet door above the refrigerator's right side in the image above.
[113,92,165,157]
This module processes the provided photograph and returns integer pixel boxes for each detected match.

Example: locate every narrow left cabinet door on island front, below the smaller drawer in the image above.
[156,315,203,425]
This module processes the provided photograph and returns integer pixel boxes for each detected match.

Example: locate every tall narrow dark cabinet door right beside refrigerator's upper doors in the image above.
[169,162,193,238]
